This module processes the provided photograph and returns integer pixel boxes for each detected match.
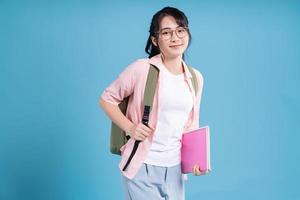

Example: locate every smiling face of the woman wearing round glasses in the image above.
[152,16,189,58]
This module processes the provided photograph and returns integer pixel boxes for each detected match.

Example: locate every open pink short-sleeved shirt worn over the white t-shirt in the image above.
[101,54,203,179]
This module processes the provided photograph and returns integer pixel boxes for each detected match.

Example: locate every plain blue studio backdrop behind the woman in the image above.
[0,0,300,200]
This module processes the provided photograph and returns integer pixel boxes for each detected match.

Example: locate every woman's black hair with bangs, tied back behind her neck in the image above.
[145,7,192,58]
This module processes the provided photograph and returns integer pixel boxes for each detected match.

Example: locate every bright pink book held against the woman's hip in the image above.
[181,126,211,174]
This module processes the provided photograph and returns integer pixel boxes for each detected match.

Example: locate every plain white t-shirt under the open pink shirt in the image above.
[144,68,193,167]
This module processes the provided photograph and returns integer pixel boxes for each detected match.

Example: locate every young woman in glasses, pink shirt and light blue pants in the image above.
[100,7,203,200]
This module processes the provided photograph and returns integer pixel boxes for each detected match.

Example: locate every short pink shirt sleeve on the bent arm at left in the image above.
[100,63,135,105]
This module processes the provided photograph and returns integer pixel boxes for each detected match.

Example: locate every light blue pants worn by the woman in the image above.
[123,163,184,200]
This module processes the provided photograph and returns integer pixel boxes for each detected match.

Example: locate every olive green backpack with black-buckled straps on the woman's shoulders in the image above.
[110,65,198,157]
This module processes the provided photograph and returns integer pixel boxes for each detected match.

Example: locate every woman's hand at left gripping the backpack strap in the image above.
[129,123,154,141]
